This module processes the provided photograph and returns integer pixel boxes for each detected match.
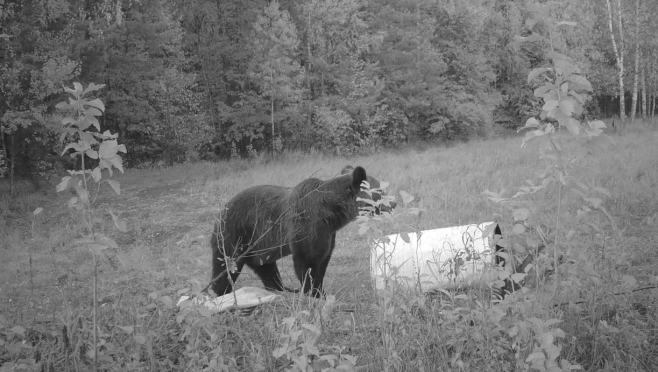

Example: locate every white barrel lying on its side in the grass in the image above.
[370,222,497,292]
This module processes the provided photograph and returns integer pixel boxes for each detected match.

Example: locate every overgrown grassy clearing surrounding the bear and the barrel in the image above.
[0,121,658,371]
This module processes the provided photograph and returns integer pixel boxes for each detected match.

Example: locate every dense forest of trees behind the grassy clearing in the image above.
[0,0,658,179]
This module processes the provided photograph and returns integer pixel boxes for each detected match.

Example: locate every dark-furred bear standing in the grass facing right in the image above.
[211,167,367,297]
